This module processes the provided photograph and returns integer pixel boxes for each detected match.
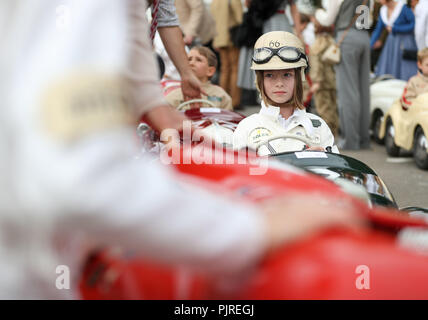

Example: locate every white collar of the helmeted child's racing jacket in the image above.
[259,101,314,136]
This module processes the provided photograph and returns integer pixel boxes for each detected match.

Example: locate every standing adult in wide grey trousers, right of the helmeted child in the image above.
[315,0,370,150]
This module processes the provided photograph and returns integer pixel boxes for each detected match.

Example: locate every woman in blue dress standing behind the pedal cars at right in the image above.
[370,0,418,81]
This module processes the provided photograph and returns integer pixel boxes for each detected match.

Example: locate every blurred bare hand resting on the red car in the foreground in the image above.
[261,193,366,250]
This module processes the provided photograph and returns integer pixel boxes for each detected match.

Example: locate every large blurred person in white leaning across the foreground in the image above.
[0,0,358,299]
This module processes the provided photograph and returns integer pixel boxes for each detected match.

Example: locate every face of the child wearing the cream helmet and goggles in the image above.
[263,69,295,104]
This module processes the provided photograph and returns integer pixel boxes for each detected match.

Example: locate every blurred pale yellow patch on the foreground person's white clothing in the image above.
[41,72,137,141]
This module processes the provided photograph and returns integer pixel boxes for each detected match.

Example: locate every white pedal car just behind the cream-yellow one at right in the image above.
[370,75,407,144]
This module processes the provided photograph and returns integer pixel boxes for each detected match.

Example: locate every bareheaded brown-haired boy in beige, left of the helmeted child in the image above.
[166,46,233,110]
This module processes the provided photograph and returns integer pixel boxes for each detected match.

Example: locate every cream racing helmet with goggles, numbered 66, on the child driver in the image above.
[251,31,308,80]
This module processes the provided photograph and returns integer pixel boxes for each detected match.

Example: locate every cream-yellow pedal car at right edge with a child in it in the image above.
[379,93,428,169]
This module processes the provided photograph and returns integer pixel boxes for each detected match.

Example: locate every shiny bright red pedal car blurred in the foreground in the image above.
[80,109,428,299]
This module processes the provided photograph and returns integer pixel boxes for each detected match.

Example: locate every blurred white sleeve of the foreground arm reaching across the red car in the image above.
[50,132,266,273]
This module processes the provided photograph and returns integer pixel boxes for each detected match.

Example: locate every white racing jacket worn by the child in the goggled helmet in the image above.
[233,101,338,155]
